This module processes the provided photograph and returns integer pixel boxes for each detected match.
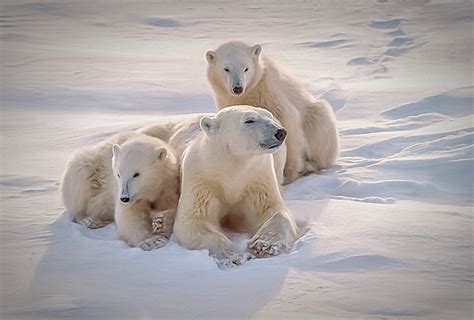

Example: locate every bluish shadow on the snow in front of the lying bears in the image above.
[25,213,300,319]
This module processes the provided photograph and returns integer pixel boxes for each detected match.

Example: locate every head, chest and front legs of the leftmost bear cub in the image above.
[112,135,179,250]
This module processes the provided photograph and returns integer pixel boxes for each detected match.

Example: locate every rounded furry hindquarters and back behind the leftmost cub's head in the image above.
[60,131,137,229]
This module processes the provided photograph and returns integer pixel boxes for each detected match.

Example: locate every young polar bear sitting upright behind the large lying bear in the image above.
[206,42,339,183]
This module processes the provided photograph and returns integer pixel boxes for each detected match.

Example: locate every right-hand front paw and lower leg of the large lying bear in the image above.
[248,211,297,258]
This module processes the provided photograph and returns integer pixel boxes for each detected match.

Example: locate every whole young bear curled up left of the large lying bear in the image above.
[61,132,179,250]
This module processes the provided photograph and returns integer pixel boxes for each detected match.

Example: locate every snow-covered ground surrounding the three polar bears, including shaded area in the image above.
[0,0,474,319]
